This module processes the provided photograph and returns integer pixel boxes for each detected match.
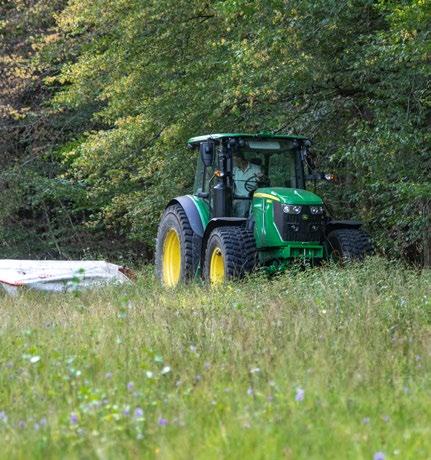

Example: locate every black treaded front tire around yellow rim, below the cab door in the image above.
[203,226,257,282]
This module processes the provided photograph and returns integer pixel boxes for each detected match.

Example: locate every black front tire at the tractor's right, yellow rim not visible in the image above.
[326,228,373,263]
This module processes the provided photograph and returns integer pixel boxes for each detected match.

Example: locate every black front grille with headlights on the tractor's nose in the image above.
[274,203,325,242]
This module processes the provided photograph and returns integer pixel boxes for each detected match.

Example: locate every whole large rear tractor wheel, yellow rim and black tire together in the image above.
[155,204,199,287]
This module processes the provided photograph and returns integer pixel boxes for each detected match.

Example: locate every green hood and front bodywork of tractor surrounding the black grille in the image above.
[251,187,323,263]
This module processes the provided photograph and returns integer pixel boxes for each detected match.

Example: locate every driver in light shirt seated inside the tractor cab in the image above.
[232,152,263,217]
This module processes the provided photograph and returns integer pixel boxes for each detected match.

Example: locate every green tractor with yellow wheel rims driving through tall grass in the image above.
[156,133,372,287]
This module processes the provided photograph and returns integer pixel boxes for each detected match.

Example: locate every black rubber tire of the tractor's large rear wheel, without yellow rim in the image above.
[155,204,200,287]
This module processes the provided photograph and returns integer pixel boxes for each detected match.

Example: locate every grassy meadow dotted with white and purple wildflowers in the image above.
[0,259,431,460]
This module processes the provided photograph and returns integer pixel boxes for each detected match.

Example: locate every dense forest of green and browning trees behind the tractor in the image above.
[0,0,431,266]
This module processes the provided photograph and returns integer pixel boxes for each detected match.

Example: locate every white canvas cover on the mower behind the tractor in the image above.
[0,259,130,294]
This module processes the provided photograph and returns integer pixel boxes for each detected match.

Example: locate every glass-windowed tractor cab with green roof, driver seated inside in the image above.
[189,134,307,217]
